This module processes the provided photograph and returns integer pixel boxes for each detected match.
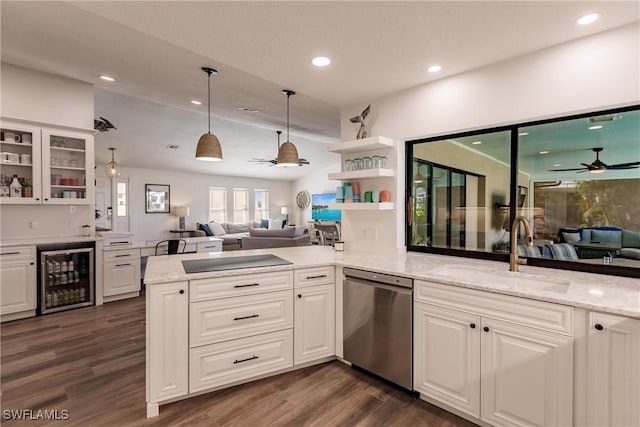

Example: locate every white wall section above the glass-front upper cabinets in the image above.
[0,62,93,129]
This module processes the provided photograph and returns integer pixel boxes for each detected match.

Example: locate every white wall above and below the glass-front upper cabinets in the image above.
[0,63,93,240]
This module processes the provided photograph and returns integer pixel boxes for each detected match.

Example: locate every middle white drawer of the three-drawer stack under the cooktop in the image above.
[189,291,293,347]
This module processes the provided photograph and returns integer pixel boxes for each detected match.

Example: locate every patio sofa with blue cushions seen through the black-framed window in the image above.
[556,227,640,260]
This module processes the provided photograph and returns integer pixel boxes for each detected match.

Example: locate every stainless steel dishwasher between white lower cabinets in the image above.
[343,268,413,391]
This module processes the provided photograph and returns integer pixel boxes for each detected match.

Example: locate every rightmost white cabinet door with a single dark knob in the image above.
[587,312,640,426]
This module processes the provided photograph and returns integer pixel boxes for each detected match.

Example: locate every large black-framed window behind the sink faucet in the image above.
[406,106,640,277]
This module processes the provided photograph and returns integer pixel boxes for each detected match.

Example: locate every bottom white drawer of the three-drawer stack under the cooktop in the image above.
[189,329,293,393]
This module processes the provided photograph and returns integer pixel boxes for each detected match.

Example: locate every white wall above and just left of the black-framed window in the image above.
[340,24,640,254]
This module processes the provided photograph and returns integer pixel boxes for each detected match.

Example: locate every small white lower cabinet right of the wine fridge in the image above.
[103,249,140,302]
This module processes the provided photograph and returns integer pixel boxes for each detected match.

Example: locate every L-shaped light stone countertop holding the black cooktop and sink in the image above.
[145,246,640,319]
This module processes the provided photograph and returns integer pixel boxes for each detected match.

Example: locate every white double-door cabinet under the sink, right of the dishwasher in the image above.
[414,281,573,426]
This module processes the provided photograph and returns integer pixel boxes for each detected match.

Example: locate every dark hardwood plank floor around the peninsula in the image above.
[0,297,474,427]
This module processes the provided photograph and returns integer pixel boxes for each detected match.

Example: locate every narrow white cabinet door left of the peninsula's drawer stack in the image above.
[146,282,189,415]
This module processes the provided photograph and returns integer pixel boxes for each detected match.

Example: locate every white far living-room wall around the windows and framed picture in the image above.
[96,165,292,241]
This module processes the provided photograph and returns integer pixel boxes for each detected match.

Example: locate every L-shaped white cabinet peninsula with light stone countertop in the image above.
[145,247,640,425]
